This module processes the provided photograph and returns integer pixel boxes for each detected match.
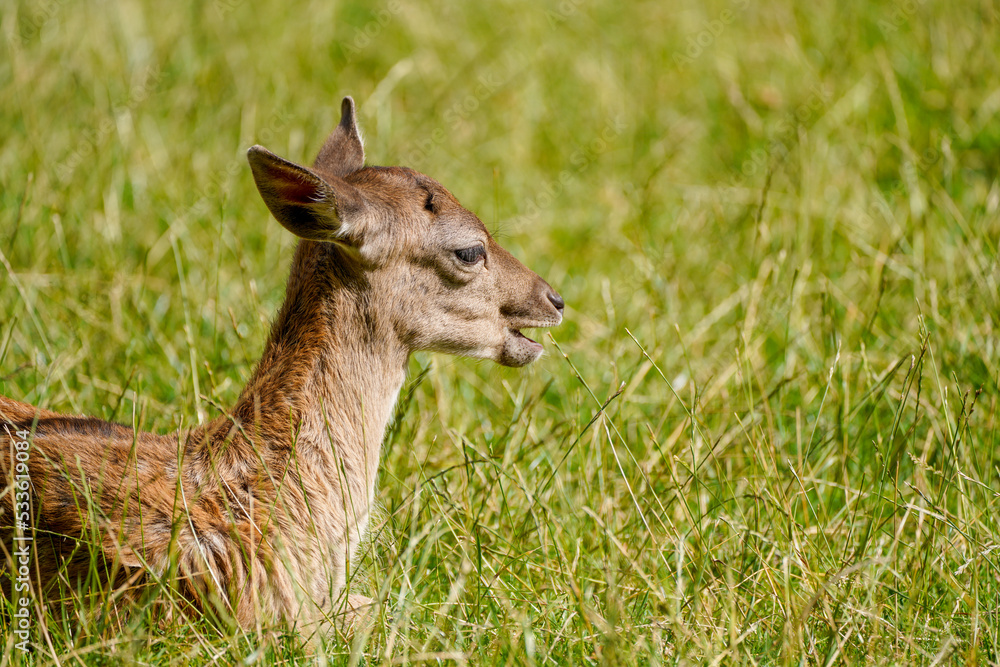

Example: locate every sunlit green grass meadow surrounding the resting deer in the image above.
[0,0,1000,666]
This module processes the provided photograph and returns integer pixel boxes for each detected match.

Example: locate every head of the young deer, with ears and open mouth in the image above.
[248,97,563,366]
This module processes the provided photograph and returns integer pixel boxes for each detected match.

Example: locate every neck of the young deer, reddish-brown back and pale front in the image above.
[223,241,409,486]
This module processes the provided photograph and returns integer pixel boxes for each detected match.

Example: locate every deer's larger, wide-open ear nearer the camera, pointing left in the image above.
[247,146,362,241]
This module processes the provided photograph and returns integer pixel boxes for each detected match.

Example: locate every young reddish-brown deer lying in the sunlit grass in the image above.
[0,97,565,632]
